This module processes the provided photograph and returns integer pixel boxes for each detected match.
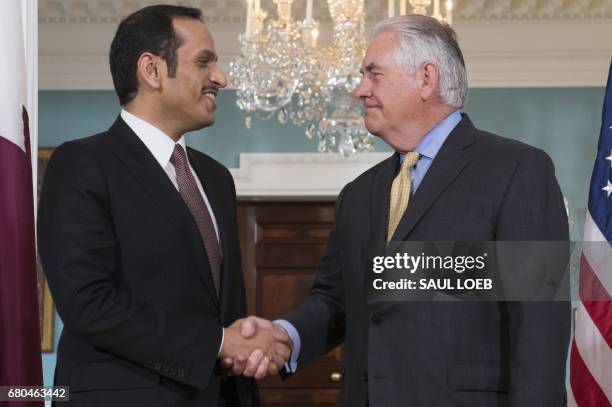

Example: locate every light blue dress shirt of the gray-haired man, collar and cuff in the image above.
[274,110,461,373]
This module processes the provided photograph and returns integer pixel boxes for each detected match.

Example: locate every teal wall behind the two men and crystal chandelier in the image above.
[39,88,604,385]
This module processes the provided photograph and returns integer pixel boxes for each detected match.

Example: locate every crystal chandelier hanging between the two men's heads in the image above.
[230,0,452,156]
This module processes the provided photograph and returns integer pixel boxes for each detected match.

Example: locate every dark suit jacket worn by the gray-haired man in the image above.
[286,116,570,407]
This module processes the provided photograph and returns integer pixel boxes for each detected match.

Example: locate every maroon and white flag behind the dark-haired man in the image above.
[0,0,43,407]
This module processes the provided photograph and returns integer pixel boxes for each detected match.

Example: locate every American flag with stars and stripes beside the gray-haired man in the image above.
[568,64,612,407]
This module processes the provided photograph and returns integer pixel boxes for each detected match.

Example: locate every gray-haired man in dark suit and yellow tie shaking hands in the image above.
[226,15,570,407]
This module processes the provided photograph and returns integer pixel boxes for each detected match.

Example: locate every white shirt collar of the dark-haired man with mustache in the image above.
[121,109,185,168]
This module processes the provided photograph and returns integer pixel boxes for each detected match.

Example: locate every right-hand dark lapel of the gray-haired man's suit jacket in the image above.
[392,115,476,241]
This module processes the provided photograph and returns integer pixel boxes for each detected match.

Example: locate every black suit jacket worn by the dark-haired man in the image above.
[38,118,256,407]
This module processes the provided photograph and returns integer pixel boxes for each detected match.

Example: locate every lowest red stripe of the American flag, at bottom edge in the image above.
[568,341,610,407]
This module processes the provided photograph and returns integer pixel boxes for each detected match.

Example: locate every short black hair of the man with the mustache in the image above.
[109,5,202,106]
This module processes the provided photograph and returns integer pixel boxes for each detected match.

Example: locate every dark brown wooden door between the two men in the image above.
[238,201,341,407]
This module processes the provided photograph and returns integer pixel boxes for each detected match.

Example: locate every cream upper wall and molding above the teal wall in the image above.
[39,0,612,90]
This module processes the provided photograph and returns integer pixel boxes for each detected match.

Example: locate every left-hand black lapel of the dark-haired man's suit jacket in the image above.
[109,118,219,307]
